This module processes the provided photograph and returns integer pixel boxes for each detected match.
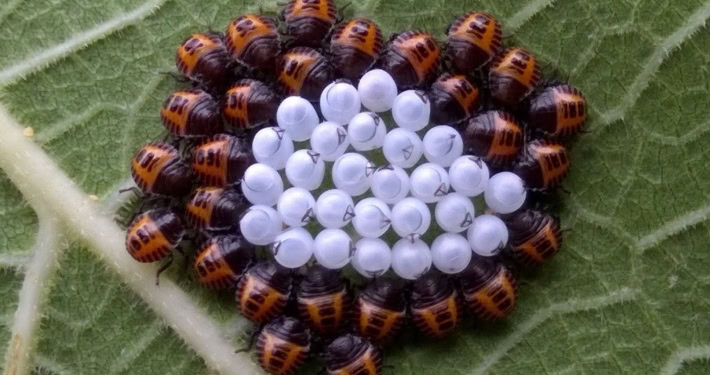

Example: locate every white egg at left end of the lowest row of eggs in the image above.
[271,228,313,268]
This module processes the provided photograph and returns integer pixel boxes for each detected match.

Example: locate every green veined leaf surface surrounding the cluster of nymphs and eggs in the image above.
[0,0,710,375]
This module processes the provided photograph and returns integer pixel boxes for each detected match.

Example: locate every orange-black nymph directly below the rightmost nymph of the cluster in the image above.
[513,139,570,190]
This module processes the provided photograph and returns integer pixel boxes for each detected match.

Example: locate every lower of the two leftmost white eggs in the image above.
[239,205,282,246]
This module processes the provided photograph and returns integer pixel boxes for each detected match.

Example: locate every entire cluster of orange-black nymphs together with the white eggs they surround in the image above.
[126,0,586,375]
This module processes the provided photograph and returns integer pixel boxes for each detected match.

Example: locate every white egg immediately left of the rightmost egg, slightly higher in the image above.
[449,155,490,197]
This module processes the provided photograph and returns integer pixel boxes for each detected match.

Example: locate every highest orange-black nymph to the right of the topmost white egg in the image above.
[446,11,502,74]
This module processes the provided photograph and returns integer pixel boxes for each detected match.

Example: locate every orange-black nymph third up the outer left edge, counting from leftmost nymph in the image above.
[160,89,224,137]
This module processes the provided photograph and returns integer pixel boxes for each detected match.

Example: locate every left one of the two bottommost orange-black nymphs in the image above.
[256,316,311,375]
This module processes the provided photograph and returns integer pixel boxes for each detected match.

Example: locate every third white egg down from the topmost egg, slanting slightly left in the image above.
[332,152,376,196]
